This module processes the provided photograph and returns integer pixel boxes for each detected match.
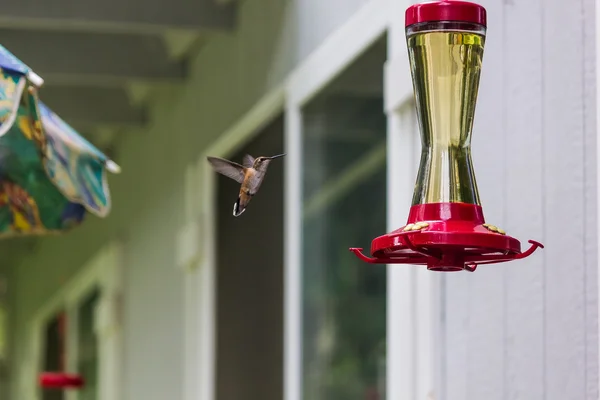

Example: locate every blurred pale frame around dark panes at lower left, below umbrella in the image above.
[21,242,124,400]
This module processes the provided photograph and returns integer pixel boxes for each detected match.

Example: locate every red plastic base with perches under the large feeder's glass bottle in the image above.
[350,203,544,272]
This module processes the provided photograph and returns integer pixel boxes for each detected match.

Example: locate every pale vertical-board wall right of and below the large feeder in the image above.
[442,0,598,400]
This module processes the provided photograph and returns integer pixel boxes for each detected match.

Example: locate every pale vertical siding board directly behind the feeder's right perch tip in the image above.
[503,0,546,400]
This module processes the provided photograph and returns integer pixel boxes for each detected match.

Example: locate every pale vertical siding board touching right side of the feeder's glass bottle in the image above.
[464,0,505,400]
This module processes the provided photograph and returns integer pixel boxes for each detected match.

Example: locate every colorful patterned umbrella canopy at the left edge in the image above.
[0,45,120,238]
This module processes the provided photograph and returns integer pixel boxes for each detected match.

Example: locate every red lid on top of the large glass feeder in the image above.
[405,0,487,26]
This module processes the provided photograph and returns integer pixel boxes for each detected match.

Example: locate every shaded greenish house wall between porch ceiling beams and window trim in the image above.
[12,0,368,400]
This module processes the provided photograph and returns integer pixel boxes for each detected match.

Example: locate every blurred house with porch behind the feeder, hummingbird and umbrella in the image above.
[0,0,599,400]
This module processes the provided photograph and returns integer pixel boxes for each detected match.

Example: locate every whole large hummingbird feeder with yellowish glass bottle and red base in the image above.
[350,0,544,272]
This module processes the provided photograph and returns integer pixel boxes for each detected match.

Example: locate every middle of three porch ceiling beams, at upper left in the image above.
[0,29,185,85]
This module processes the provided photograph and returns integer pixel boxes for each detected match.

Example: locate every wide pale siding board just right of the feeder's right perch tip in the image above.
[540,1,586,400]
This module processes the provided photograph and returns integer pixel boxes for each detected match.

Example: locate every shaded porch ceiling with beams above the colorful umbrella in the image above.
[0,0,238,152]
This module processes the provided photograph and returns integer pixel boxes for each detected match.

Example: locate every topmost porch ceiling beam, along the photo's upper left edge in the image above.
[0,0,236,33]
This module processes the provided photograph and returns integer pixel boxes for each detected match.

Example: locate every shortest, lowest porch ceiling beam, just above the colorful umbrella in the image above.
[39,86,146,129]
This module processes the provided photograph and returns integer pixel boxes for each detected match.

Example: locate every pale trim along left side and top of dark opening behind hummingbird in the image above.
[184,86,287,400]
